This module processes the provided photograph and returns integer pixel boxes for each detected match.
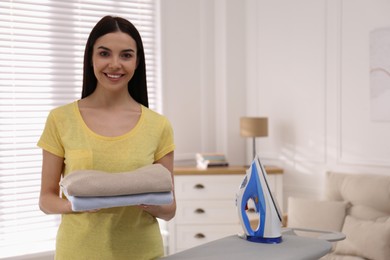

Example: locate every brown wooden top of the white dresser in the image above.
[173,165,283,175]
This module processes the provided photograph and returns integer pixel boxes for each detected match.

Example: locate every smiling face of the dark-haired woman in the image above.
[92,32,137,91]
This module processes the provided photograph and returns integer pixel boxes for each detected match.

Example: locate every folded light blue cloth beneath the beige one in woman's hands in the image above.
[65,192,173,211]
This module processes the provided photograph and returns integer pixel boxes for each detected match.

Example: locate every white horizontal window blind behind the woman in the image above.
[0,0,160,258]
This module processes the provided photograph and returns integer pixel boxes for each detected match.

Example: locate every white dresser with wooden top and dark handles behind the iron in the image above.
[168,166,283,254]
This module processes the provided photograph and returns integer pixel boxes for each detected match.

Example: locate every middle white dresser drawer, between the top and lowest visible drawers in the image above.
[175,200,239,224]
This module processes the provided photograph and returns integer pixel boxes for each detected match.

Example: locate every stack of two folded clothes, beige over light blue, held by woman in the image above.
[60,164,173,211]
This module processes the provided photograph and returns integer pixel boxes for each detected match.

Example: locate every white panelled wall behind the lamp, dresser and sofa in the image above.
[161,0,390,209]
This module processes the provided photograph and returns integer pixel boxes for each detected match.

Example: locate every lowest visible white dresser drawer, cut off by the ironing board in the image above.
[176,222,242,251]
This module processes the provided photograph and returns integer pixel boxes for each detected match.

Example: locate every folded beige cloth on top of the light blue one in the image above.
[60,164,173,197]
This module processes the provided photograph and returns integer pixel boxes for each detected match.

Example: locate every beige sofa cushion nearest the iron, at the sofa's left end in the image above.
[287,197,348,231]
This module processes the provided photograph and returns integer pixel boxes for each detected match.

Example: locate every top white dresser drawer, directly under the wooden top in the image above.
[175,175,244,201]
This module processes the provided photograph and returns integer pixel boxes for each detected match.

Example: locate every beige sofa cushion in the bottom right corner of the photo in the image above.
[334,216,390,260]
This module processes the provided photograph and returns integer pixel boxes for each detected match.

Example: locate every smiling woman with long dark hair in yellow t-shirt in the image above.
[38,16,176,260]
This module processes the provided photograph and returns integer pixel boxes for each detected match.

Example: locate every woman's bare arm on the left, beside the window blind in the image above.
[39,150,72,214]
